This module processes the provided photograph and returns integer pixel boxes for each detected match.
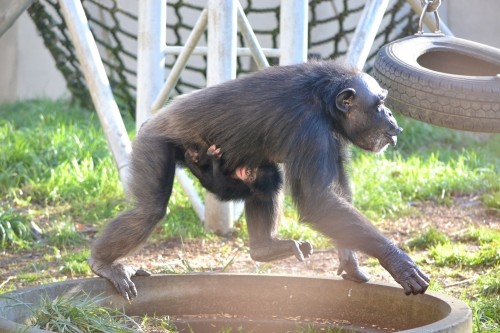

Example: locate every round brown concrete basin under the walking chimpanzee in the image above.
[0,273,472,333]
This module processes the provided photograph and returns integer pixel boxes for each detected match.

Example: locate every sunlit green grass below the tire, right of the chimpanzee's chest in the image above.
[351,119,500,220]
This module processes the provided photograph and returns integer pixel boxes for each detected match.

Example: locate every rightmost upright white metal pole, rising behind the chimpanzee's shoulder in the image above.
[280,0,309,65]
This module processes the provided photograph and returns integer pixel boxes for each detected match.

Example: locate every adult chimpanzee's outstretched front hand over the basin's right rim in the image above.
[379,244,430,295]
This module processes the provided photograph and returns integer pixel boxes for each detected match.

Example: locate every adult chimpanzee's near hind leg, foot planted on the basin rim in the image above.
[89,135,176,299]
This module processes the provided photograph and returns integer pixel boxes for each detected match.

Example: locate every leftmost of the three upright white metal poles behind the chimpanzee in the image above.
[135,0,167,130]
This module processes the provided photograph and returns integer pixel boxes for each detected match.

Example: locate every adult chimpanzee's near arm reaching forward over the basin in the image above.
[285,131,429,294]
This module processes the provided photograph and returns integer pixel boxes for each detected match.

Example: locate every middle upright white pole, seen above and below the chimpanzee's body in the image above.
[205,0,237,234]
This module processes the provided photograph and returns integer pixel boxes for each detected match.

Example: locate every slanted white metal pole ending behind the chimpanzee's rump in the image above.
[59,0,132,190]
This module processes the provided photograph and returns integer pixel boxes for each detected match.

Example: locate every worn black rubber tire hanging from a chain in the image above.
[373,36,500,132]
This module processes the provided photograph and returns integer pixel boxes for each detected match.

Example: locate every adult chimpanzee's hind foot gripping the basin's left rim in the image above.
[89,258,151,302]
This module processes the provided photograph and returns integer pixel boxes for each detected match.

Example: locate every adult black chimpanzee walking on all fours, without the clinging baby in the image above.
[89,61,429,298]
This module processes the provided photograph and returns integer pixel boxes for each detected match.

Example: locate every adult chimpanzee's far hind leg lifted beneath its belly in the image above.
[245,189,312,261]
